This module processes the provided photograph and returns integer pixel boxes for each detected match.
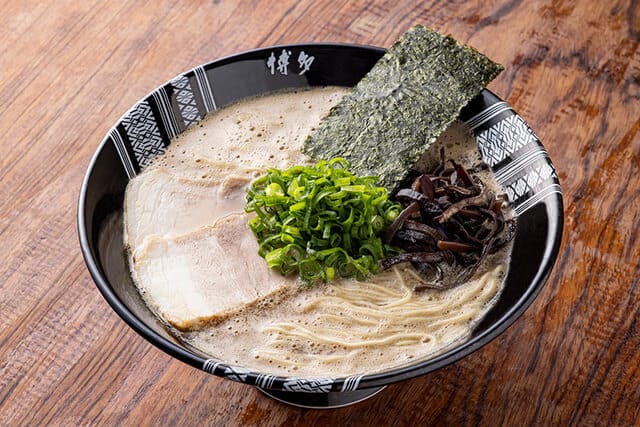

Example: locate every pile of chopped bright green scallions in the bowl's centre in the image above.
[245,158,402,284]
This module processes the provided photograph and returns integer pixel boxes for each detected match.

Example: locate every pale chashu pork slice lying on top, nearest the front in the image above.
[132,214,297,331]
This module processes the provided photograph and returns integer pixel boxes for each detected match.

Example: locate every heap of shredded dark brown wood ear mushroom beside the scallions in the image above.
[380,149,515,290]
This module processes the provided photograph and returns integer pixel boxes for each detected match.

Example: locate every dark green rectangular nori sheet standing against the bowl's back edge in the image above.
[302,26,503,192]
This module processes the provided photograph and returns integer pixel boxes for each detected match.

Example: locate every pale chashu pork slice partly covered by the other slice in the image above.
[124,168,250,255]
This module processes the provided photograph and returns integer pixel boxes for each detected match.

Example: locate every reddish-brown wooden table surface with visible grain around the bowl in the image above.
[0,0,640,426]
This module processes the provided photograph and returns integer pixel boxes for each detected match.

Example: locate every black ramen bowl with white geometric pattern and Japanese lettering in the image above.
[78,44,563,408]
